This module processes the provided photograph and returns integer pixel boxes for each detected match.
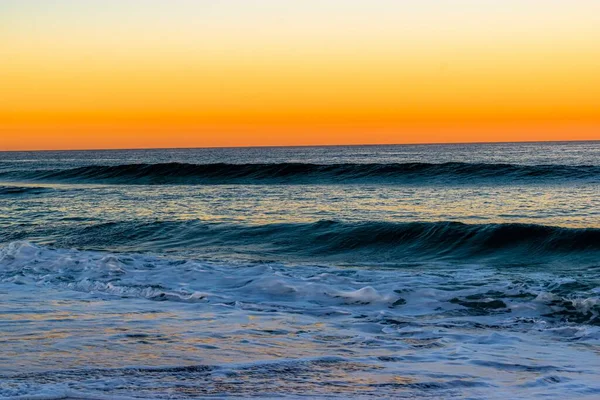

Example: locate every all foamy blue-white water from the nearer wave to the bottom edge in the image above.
[0,242,600,399]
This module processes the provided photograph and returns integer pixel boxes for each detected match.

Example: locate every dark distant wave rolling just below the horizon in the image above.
[0,162,600,185]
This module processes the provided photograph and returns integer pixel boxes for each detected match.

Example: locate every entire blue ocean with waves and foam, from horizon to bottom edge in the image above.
[0,142,600,399]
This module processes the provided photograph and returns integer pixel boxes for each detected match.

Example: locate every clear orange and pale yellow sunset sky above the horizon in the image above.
[0,0,600,150]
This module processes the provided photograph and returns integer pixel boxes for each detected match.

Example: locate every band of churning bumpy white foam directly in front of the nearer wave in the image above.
[0,242,599,323]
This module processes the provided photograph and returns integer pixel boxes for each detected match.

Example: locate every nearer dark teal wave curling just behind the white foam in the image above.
[0,220,600,264]
